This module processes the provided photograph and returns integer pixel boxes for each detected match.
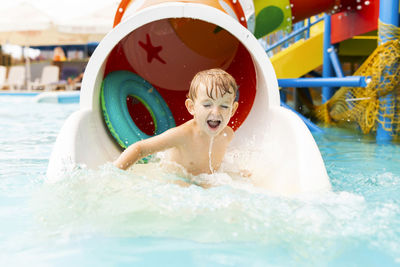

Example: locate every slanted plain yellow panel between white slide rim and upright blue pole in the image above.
[271,31,323,79]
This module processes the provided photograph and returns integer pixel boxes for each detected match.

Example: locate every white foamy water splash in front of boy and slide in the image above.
[26,161,400,258]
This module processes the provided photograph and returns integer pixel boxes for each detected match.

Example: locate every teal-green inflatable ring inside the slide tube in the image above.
[101,70,175,148]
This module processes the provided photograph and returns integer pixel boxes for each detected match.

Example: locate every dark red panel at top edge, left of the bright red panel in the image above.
[290,0,337,23]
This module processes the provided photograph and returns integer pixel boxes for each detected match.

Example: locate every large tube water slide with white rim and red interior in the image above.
[47,0,330,195]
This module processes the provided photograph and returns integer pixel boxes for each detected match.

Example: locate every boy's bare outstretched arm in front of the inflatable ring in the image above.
[113,127,183,170]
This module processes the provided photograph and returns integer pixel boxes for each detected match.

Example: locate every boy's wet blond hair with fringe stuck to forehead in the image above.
[187,69,238,101]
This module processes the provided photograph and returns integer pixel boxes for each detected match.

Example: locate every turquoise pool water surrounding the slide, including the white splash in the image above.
[0,96,400,266]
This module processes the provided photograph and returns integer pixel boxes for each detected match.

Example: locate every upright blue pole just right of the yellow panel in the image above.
[322,14,334,103]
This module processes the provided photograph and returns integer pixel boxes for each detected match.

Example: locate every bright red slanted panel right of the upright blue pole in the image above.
[331,0,379,44]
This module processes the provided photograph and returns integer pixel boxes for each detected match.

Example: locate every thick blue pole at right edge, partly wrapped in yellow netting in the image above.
[376,0,399,143]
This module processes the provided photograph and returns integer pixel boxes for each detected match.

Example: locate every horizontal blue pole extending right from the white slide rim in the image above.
[278,76,367,87]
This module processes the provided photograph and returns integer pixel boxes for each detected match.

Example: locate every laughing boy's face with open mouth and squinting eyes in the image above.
[185,84,238,136]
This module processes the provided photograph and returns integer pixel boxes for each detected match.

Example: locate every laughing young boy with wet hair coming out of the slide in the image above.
[114,69,238,181]
